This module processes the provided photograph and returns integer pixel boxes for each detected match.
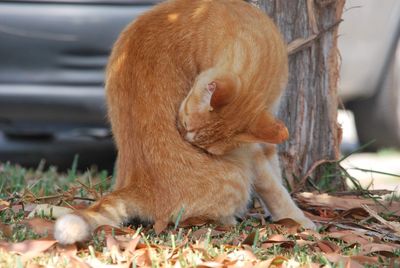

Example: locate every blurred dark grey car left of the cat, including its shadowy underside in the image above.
[0,0,157,168]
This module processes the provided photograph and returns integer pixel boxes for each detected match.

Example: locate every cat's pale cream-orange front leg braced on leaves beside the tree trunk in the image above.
[254,145,316,229]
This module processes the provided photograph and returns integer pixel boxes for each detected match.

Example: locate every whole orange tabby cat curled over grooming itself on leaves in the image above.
[55,0,314,244]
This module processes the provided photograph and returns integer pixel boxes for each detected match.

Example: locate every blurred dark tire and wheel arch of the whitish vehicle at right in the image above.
[346,39,400,150]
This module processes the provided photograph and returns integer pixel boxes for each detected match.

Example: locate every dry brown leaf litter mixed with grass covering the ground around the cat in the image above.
[0,163,400,267]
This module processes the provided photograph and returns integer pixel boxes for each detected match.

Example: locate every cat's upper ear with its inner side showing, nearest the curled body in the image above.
[205,75,237,110]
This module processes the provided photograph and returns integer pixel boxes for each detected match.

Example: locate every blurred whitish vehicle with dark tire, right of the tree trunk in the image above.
[338,0,400,149]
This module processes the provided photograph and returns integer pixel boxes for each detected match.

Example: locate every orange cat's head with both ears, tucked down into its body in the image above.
[178,76,289,155]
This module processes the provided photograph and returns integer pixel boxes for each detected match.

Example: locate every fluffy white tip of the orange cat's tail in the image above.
[54,214,90,245]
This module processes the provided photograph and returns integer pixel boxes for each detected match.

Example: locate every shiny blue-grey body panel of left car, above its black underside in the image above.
[0,1,154,133]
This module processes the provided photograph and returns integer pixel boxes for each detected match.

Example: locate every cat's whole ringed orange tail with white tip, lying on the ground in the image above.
[54,187,147,244]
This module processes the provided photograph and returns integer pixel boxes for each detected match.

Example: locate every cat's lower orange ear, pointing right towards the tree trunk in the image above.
[237,112,289,144]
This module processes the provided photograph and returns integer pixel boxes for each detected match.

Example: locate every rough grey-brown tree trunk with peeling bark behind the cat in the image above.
[249,0,345,190]
